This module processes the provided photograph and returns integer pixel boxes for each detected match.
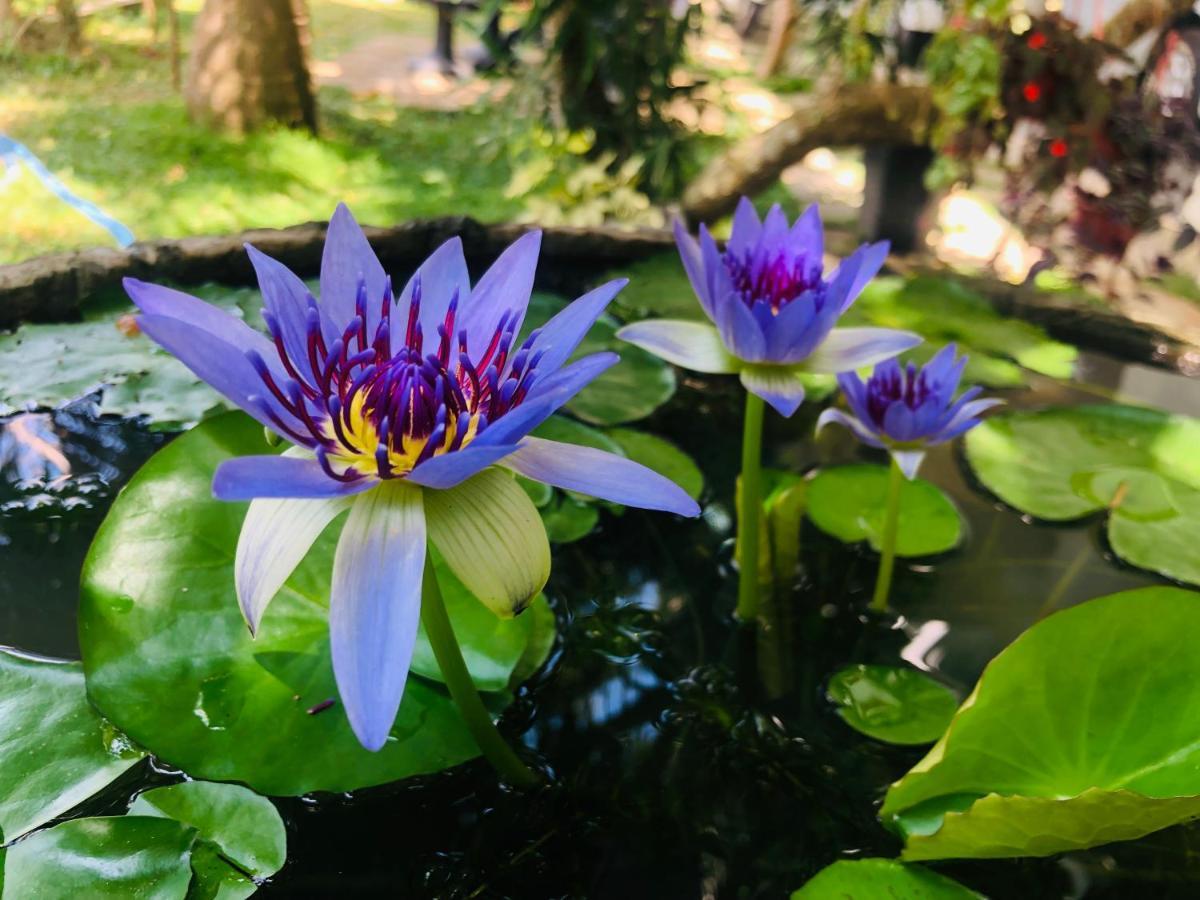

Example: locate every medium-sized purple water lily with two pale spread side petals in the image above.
[617,197,920,415]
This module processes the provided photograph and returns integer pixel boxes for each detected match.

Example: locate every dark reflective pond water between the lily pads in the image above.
[0,358,1200,899]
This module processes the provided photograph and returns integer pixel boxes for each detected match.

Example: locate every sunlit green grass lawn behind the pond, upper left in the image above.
[0,0,520,263]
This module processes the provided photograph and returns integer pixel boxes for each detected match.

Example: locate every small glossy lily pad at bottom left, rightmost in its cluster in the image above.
[130,781,287,900]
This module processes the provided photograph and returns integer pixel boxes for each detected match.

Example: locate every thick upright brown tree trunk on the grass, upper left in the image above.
[185,0,317,133]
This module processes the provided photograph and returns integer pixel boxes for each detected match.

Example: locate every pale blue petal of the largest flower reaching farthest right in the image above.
[504,437,700,516]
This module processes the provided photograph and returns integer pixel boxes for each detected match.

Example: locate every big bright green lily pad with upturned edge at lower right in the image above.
[880,587,1200,859]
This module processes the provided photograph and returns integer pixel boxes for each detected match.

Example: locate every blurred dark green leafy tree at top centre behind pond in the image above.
[500,0,694,194]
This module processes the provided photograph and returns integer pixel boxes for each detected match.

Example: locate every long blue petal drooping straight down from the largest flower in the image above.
[329,482,425,750]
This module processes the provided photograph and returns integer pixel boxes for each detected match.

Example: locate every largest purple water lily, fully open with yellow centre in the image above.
[125,205,700,750]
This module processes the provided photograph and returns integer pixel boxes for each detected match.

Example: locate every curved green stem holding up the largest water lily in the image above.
[421,557,541,787]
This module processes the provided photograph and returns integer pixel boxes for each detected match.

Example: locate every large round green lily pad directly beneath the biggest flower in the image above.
[79,414,552,794]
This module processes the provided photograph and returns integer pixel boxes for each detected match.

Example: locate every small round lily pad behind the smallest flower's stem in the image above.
[808,463,962,557]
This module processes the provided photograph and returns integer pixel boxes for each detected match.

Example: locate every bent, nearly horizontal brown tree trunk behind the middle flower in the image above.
[683,84,935,221]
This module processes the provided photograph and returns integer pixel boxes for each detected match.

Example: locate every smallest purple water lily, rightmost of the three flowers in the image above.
[817,344,1004,480]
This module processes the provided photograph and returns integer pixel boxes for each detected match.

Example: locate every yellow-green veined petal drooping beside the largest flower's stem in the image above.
[425,468,550,618]
